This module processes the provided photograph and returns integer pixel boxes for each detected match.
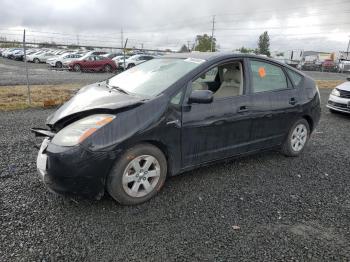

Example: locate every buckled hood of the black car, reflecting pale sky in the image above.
[46,83,144,125]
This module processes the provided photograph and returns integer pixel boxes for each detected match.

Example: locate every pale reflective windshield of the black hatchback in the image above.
[109,58,204,96]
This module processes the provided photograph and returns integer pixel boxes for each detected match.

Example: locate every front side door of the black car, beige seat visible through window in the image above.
[181,60,251,167]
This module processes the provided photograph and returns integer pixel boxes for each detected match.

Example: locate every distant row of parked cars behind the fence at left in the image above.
[0,48,159,72]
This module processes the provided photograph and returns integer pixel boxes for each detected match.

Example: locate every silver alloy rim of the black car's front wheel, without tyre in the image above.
[122,155,160,197]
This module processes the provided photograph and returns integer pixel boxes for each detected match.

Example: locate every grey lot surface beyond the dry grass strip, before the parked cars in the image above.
[0,57,350,86]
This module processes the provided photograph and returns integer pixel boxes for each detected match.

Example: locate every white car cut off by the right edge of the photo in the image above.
[327,77,350,113]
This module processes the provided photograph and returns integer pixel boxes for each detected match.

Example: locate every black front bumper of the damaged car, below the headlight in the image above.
[37,138,113,198]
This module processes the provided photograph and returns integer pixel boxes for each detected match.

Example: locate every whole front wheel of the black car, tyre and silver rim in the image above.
[107,144,167,205]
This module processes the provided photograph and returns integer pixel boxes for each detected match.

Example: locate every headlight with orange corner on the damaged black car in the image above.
[52,114,115,146]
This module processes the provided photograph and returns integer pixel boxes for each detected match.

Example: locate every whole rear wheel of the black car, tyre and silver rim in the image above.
[281,119,310,157]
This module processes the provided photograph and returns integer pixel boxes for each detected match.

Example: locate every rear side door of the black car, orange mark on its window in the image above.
[249,59,301,149]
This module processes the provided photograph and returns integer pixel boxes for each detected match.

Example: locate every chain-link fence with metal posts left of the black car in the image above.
[0,31,169,109]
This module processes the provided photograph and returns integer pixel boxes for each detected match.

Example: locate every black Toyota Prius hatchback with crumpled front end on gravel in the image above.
[32,53,320,205]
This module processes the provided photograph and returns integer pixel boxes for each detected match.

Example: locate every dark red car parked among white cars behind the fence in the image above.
[68,55,117,72]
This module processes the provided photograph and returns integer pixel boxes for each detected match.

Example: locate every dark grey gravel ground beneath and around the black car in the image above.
[0,90,350,261]
